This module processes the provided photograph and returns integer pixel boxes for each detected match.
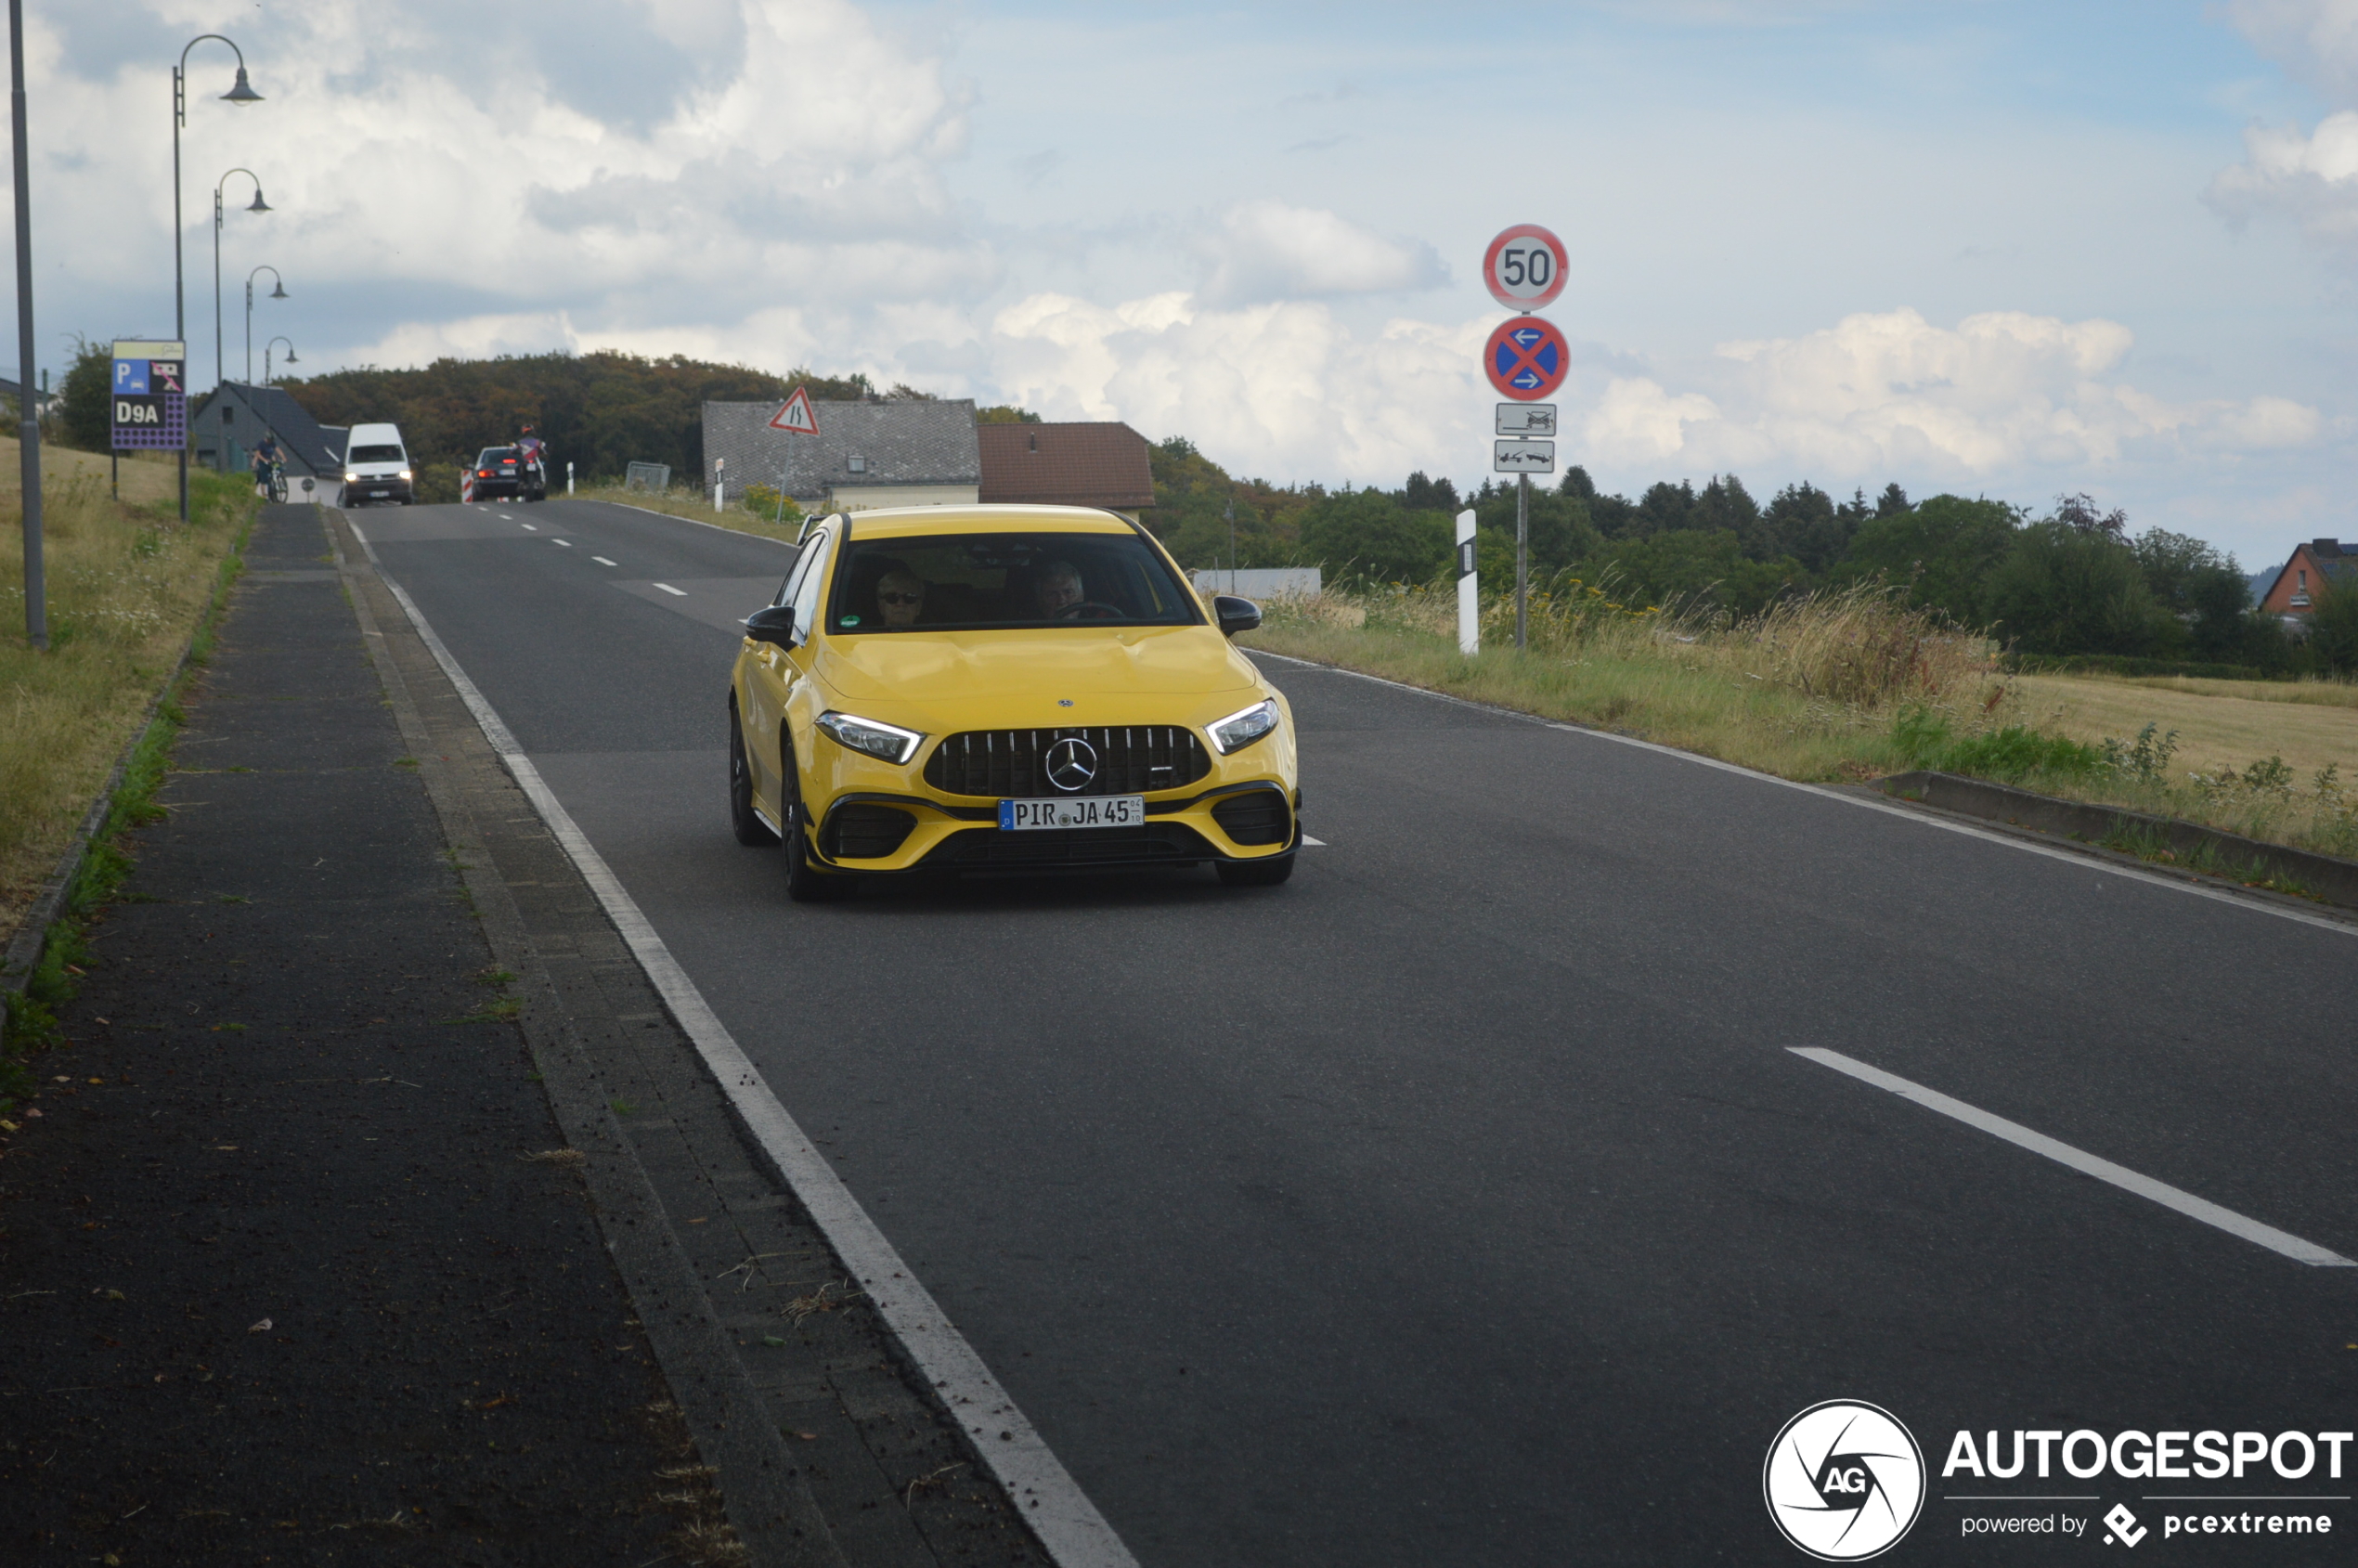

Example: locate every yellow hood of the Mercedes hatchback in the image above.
[813,628,1262,705]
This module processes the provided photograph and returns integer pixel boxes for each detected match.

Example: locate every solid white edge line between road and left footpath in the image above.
[346,516,1139,1568]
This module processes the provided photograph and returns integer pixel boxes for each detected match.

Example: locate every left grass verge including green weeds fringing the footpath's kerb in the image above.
[0,443,257,1110]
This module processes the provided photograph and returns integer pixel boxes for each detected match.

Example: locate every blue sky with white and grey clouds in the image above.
[9,0,2358,566]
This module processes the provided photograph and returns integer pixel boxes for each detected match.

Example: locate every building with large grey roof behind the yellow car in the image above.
[703,398,983,512]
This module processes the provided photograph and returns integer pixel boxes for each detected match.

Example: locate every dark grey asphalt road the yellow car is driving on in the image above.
[354,502,2358,1568]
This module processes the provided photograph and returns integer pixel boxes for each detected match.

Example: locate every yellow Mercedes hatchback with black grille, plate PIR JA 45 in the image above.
[729,507,1302,901]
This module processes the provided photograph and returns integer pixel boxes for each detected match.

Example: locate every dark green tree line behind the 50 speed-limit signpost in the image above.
[1153,436,2358,674]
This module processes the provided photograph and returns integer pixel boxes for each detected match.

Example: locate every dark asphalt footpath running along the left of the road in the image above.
[0,507,1038,1568]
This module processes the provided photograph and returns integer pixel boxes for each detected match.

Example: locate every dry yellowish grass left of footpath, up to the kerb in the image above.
[0,438,254,943]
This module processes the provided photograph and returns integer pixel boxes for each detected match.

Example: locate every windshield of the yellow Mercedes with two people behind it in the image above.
[828,528,1202,634]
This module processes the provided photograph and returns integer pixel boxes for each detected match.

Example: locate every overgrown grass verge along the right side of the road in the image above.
[1240,580,2358,858]
